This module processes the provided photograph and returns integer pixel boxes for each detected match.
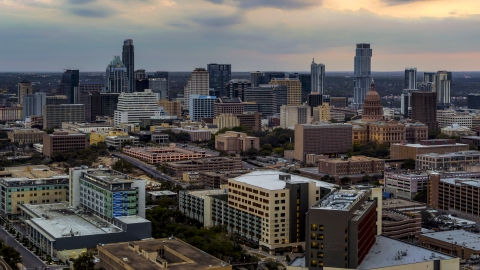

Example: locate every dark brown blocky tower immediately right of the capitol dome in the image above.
[411,92,438,132]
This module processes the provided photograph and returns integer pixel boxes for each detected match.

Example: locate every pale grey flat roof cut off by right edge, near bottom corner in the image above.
[422,230,480,250]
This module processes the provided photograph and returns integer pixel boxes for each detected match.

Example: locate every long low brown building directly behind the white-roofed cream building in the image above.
[166,157,243,177]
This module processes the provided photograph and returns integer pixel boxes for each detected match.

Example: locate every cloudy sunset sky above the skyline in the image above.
[0,0,480,72]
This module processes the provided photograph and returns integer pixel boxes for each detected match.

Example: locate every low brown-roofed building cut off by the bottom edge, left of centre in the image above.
[97,238,232,270]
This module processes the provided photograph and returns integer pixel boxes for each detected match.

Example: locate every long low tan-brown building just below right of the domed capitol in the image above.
[390,139,469,159]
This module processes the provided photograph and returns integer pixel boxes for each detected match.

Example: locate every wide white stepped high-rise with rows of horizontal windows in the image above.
[114,89,160,126]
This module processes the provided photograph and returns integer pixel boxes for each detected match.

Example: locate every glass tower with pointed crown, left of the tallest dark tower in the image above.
[103,55,130,93]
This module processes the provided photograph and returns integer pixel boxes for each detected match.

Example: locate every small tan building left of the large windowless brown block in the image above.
[215,131,260,154]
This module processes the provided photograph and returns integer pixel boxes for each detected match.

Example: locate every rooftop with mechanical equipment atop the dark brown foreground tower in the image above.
[312,189,367,211]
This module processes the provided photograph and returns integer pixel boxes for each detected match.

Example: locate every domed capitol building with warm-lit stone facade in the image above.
[350,82,428,145]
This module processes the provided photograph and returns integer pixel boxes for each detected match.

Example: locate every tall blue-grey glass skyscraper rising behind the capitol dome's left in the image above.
[353,43,372,107]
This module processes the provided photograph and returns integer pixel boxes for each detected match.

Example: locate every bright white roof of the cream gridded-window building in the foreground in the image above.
[233,170,338,190]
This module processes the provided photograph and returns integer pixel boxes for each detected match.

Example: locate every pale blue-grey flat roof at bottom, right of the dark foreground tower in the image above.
[357,235,454,269]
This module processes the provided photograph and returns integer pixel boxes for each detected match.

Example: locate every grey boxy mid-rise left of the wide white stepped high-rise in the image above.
[43,104,85,129]
